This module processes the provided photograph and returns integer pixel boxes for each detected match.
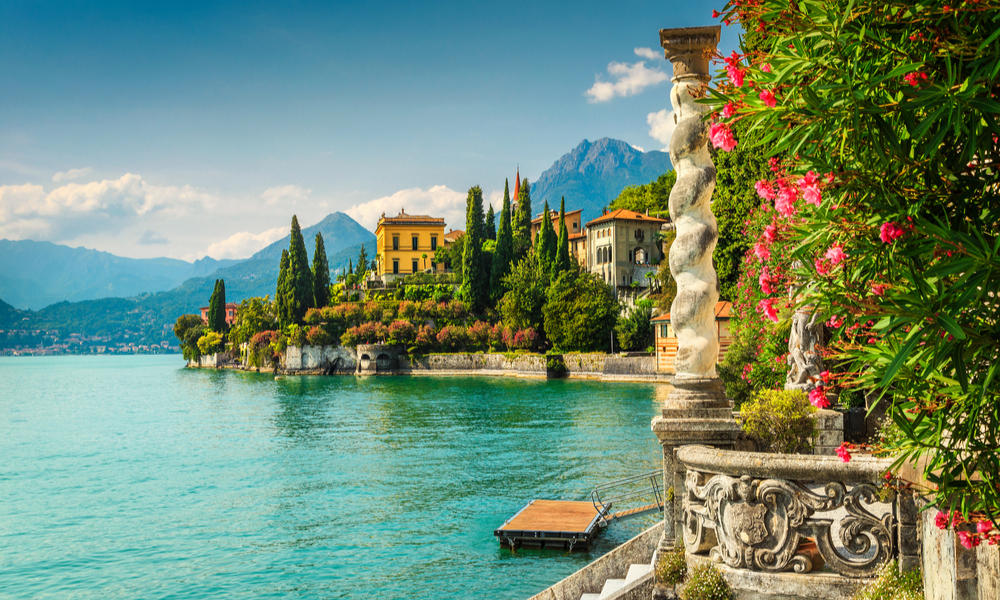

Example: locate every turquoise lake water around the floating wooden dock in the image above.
[0,356,660,599]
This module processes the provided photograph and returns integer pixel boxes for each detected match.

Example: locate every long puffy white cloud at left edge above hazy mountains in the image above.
[0,173,216,241]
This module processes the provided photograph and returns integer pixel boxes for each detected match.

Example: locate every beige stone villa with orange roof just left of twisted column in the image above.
[584,208,669,289]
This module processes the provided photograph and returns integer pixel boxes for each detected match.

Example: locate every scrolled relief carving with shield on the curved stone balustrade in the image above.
[683,470,895,577]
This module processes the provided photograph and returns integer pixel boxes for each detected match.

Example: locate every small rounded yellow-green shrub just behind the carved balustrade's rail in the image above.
[741,390,816,454]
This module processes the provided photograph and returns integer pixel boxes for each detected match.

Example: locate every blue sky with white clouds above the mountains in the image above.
[0,0,737,261]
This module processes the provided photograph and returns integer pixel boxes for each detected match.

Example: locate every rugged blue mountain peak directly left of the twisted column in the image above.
[530,138,672,222]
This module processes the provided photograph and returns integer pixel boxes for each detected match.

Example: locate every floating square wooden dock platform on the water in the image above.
[493,500,606,550]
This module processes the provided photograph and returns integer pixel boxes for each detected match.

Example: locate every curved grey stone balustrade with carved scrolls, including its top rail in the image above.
[674,446,919,598]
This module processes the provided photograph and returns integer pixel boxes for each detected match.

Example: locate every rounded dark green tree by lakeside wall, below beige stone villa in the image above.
[543,269,619,351]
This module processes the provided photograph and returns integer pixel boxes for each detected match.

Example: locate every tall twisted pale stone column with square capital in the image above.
[652,26,740,548]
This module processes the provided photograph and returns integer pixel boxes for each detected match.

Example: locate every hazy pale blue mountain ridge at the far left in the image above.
[0,240,238,309]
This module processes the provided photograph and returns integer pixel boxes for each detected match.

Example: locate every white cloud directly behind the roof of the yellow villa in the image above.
[344,185,466,231]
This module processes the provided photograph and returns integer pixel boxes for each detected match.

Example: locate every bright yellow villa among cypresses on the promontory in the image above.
[375,210,444,283]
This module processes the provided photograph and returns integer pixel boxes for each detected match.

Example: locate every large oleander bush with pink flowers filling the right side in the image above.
[711,0,1000,518]
